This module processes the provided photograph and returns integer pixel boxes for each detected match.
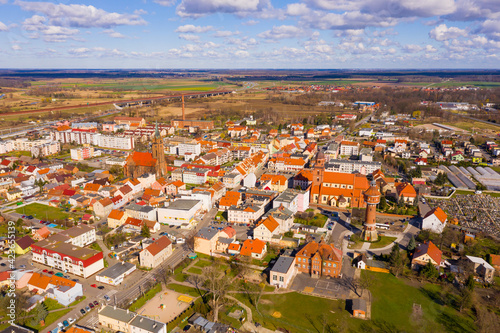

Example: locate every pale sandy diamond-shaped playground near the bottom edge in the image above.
[137,290,194,323]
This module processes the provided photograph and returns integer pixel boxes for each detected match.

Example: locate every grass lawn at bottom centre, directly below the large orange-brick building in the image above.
[233,292,362,333]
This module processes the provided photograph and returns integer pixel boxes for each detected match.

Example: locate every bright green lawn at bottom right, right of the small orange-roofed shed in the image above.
[361,270,476,332]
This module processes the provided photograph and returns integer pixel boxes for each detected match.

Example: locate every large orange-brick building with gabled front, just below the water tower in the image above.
[295,241,342,278]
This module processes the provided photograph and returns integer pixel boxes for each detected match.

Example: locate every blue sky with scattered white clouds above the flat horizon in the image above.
[0,0,500,69]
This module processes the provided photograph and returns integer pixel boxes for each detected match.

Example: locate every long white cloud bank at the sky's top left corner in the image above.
[15,1,146,28]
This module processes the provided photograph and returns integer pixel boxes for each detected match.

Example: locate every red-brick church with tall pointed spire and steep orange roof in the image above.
[124,124,167,178]
